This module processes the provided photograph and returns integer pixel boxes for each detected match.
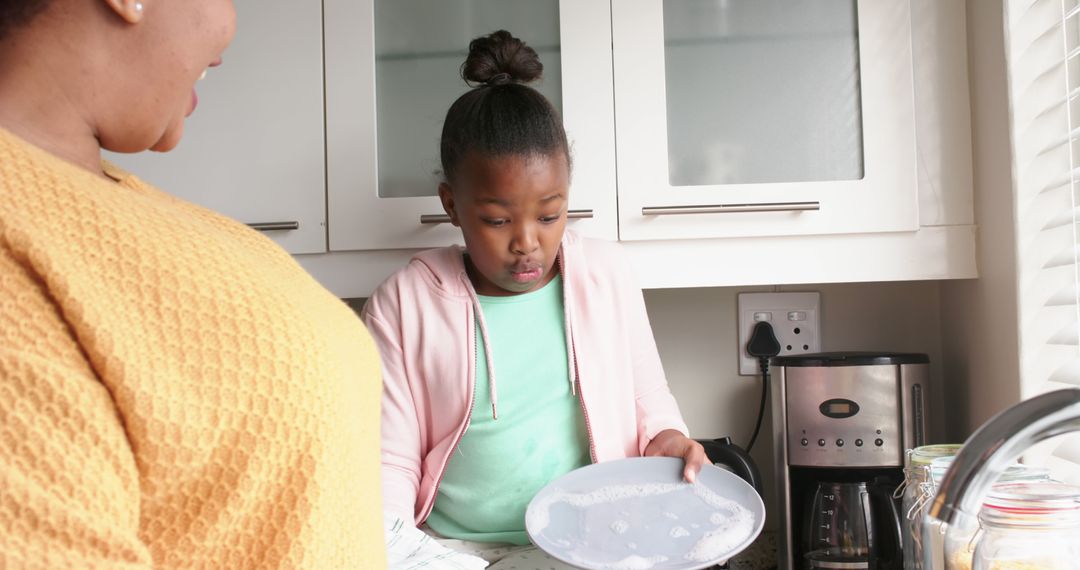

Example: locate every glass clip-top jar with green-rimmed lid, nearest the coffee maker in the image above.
[894,444,960,570]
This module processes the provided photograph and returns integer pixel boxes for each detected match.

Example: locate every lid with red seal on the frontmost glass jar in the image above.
[980,481,1080,527]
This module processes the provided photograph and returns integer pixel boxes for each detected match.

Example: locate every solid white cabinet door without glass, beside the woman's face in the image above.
[108,0,326,254]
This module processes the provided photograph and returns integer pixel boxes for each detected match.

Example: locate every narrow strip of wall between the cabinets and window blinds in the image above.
[942,0,1020,437]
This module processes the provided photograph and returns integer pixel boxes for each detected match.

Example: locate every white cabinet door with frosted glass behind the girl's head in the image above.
[324,0,618,250]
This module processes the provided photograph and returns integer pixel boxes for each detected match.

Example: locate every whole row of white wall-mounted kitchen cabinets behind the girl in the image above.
[114,0,977,297]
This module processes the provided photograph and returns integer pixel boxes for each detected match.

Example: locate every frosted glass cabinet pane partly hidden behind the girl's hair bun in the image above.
[375,0,563,198]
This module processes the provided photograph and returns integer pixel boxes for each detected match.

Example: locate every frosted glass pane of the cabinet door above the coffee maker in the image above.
[664,0,863,186]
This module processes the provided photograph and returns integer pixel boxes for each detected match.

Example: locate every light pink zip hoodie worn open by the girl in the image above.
[362,230,687,525]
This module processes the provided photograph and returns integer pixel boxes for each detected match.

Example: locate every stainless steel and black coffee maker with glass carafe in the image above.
[770,352,930,570]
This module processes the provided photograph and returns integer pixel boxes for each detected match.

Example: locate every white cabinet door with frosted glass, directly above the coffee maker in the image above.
[612,0,919,240]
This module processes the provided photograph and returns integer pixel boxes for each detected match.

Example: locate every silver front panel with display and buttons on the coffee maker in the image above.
[785,366,904,467]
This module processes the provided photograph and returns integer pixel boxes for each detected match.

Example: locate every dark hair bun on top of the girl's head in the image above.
[461,30,543,85]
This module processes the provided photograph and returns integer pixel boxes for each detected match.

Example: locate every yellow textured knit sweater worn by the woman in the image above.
[0,130,386,569]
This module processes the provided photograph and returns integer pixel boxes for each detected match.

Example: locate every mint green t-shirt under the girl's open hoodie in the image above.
[428,276,590,544]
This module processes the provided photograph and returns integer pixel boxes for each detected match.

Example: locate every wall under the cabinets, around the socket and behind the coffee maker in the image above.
[645,282,944,528]
